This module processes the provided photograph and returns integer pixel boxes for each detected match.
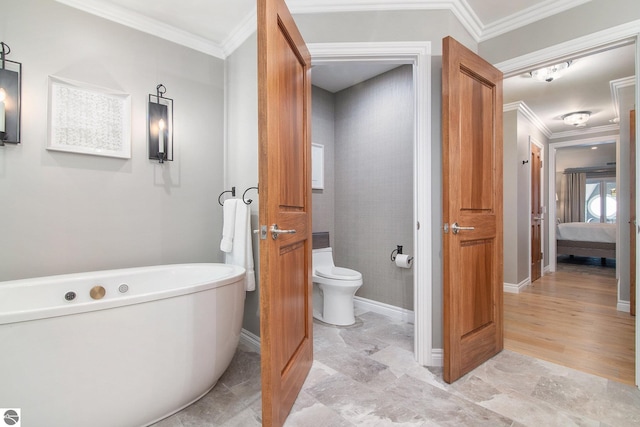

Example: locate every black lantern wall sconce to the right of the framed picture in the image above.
[148,83,173,163]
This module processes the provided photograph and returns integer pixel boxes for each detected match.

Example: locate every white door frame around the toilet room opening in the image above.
[307,42,442,366]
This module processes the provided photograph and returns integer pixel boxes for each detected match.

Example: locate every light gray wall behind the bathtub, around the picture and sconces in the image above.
[0,0,224,280]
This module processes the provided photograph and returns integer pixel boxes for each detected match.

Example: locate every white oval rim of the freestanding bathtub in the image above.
[0,263,246,326]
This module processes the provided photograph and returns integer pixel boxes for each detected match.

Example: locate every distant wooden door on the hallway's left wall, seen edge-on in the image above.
[530,144,544,282]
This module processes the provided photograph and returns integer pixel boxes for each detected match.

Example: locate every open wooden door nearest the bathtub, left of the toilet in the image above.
[258,0,313,426]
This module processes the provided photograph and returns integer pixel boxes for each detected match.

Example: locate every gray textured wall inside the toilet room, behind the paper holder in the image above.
[332,65,414,310]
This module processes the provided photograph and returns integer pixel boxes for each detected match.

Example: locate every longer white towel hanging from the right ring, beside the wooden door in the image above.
[225,200,256,291]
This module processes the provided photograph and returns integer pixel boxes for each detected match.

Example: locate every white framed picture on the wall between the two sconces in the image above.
[47,76,131,159]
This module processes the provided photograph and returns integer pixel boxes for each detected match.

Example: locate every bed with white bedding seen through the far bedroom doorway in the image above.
[556,222,616,261]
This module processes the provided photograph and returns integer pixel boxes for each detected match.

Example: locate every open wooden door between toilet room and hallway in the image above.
[442,37,504,383]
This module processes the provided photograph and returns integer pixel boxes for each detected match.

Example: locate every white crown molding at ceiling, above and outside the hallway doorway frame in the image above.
[478,0,591,41]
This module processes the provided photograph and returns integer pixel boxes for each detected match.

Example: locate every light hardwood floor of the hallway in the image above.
[504,263,635,385]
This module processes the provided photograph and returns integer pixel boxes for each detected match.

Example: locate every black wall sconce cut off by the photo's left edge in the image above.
[0,42,22,146]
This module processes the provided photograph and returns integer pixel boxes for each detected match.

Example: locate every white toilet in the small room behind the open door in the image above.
[313,247,362,326]
